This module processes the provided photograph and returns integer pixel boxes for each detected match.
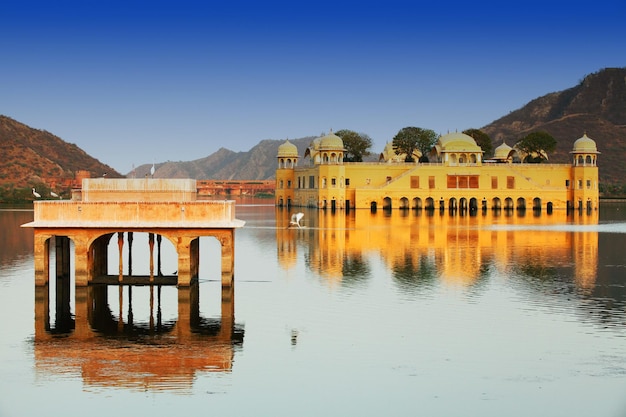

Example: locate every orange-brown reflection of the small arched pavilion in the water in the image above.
[34,279,244,391]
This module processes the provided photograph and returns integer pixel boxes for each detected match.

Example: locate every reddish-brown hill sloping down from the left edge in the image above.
[0,115,121,201]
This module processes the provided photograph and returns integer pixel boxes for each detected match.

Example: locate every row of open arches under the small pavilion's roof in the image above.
[36,231,233,286]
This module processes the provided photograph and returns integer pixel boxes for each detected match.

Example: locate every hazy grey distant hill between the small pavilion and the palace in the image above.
[133,136,315,180]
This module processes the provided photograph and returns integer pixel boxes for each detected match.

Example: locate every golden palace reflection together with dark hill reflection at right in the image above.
[276,209,626,326]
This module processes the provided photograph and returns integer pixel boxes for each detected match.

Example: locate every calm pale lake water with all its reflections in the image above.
[0,200,626,417]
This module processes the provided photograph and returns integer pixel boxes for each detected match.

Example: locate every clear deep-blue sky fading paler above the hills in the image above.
[0,0,626,173]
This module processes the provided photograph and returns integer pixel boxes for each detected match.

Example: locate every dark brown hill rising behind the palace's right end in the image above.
[481,68,626,184]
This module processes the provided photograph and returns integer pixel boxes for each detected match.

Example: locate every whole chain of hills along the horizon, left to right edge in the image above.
[0,68,626,201]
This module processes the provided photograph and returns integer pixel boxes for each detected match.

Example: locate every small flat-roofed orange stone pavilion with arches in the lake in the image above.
[22,178,245,287]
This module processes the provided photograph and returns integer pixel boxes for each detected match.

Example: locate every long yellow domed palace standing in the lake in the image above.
[276,131,599,212]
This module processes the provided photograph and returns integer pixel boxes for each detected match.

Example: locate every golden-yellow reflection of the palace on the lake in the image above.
[276,208,598,289]
